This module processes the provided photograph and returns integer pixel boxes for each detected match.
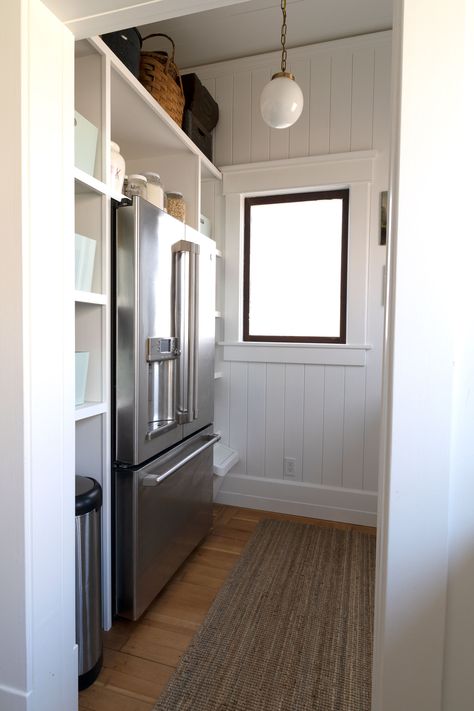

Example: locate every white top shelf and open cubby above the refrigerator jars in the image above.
[76,37,222,180]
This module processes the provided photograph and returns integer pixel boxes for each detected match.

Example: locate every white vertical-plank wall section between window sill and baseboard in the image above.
[216,362,370,490]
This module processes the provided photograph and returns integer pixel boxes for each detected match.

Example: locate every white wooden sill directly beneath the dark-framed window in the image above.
[218,341,372,366]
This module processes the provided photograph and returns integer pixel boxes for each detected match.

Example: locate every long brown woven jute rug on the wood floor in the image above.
[154,520,375,711]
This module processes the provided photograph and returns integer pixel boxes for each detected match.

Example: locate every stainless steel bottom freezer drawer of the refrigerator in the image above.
[115,427,219,620]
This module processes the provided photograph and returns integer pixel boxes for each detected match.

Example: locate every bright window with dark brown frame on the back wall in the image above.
[243,189,349,343]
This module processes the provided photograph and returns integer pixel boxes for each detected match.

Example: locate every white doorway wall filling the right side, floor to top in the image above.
[373,0,474,711]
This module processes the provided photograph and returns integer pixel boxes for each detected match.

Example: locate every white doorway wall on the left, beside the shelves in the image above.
[0,0,77,711]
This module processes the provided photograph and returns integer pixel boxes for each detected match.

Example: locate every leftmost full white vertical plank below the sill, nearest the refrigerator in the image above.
[229,363,248,474]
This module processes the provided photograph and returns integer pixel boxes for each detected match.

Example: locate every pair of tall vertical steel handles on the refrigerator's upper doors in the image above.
[173,240,199,425]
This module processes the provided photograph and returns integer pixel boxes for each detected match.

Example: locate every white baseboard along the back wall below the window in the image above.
[216,474,377,526]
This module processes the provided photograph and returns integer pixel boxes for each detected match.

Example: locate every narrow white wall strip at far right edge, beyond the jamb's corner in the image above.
[443,0,474,711]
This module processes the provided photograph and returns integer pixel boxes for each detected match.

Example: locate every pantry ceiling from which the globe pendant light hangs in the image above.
[139,0,392,68]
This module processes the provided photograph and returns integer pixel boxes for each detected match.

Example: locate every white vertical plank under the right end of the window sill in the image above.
[342,368,366,489]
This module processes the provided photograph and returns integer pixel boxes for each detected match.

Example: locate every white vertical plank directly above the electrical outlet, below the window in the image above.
[283,365,305,481]
